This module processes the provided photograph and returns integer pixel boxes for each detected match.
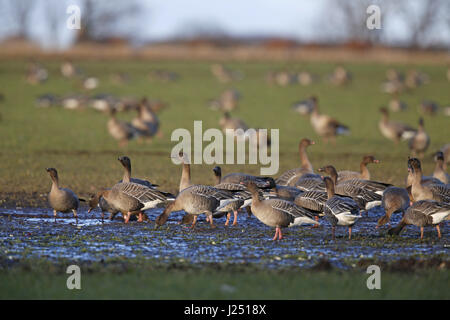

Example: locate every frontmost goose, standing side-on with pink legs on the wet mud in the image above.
[241,181,319,240]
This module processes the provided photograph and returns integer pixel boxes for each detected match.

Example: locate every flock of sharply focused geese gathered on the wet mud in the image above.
[46,139,450,240]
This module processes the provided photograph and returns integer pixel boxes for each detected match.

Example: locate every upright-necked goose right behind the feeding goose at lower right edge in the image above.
[408,158,450,202]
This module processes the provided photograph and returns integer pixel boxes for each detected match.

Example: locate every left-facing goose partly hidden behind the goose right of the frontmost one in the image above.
[319,165,384,210]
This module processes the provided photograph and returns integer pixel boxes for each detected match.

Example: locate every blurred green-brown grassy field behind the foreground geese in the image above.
[0,61,450,206]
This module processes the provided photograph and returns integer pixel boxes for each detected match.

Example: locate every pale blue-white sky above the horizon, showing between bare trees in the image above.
[0,0,450,48]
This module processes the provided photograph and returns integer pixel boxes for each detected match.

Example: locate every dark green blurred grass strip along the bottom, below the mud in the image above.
[0,270,450,299]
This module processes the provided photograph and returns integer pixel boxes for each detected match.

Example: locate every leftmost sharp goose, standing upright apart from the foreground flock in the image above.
[45,168,80,224]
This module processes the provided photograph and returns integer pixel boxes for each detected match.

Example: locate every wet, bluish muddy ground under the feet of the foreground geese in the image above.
[0,207,450,269]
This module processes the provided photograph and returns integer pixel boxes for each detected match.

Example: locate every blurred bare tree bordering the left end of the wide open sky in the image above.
[77,0,142,42]
